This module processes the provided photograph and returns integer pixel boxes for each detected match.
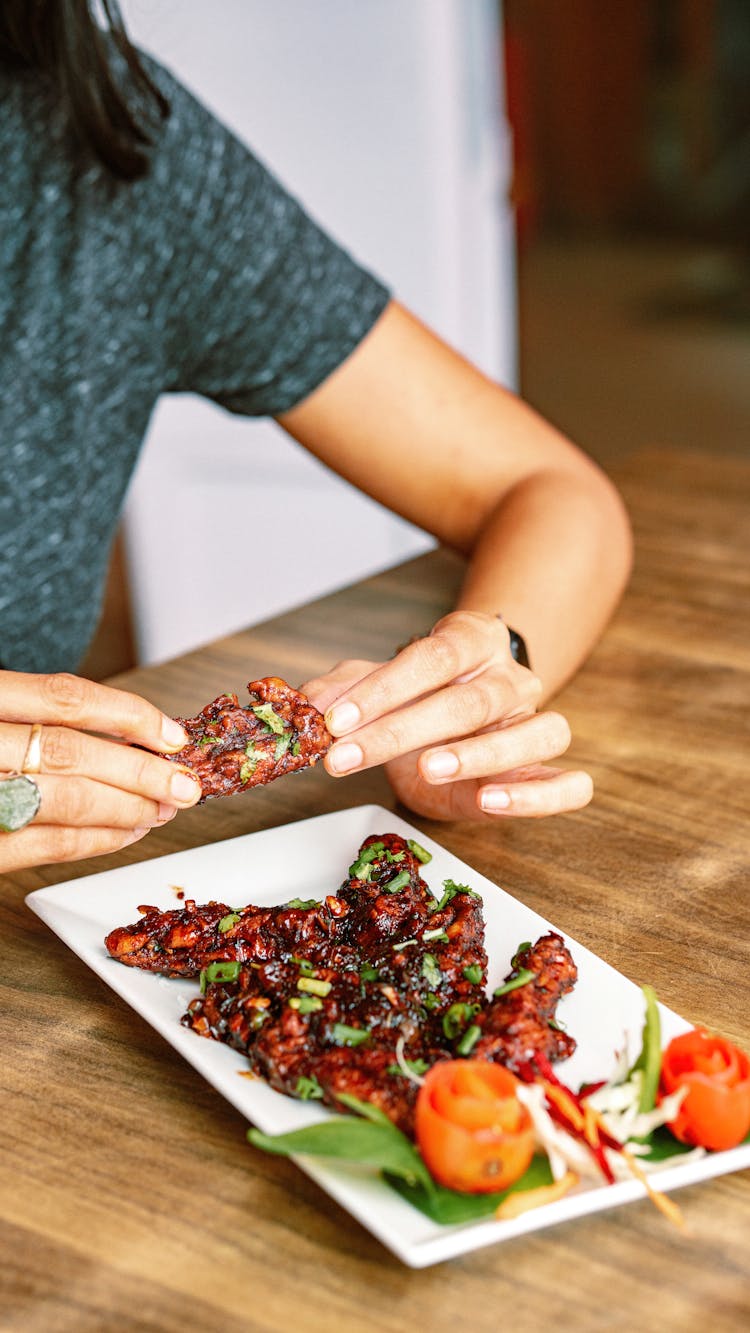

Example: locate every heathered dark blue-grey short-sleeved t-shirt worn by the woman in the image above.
[0,61,388,670]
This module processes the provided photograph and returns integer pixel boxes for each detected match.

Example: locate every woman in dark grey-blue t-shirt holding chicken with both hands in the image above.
[0,0,630,870]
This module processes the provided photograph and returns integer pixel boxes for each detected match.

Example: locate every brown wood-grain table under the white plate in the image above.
[0,452,750,1333]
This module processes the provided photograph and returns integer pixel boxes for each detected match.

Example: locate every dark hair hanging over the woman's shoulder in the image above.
[0,0,169,180]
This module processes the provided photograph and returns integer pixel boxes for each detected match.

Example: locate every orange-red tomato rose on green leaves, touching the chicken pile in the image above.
[416,1060,534,1194]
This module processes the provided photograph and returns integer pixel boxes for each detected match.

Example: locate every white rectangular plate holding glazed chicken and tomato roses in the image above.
[27,805,750,1268]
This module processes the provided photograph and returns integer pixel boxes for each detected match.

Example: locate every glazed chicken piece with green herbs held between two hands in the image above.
[164,676,333,801]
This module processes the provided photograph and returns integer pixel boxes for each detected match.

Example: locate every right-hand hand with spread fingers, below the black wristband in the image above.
[302,611,593,820]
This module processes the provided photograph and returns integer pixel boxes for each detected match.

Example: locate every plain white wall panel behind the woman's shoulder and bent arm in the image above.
[123,0,516,661]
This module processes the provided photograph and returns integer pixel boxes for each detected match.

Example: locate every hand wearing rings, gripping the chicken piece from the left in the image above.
[0,672,201,873]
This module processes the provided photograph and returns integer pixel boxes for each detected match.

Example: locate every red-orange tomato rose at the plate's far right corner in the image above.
[661,1028,750,1150]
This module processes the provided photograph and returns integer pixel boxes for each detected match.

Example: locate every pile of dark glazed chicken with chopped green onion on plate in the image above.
[105,833,575,1133]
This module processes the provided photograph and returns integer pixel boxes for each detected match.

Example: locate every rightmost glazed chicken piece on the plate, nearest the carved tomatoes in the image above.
[472,930,578,1076]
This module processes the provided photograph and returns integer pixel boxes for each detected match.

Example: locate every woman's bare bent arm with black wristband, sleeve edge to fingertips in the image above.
[280,304,631,817]
